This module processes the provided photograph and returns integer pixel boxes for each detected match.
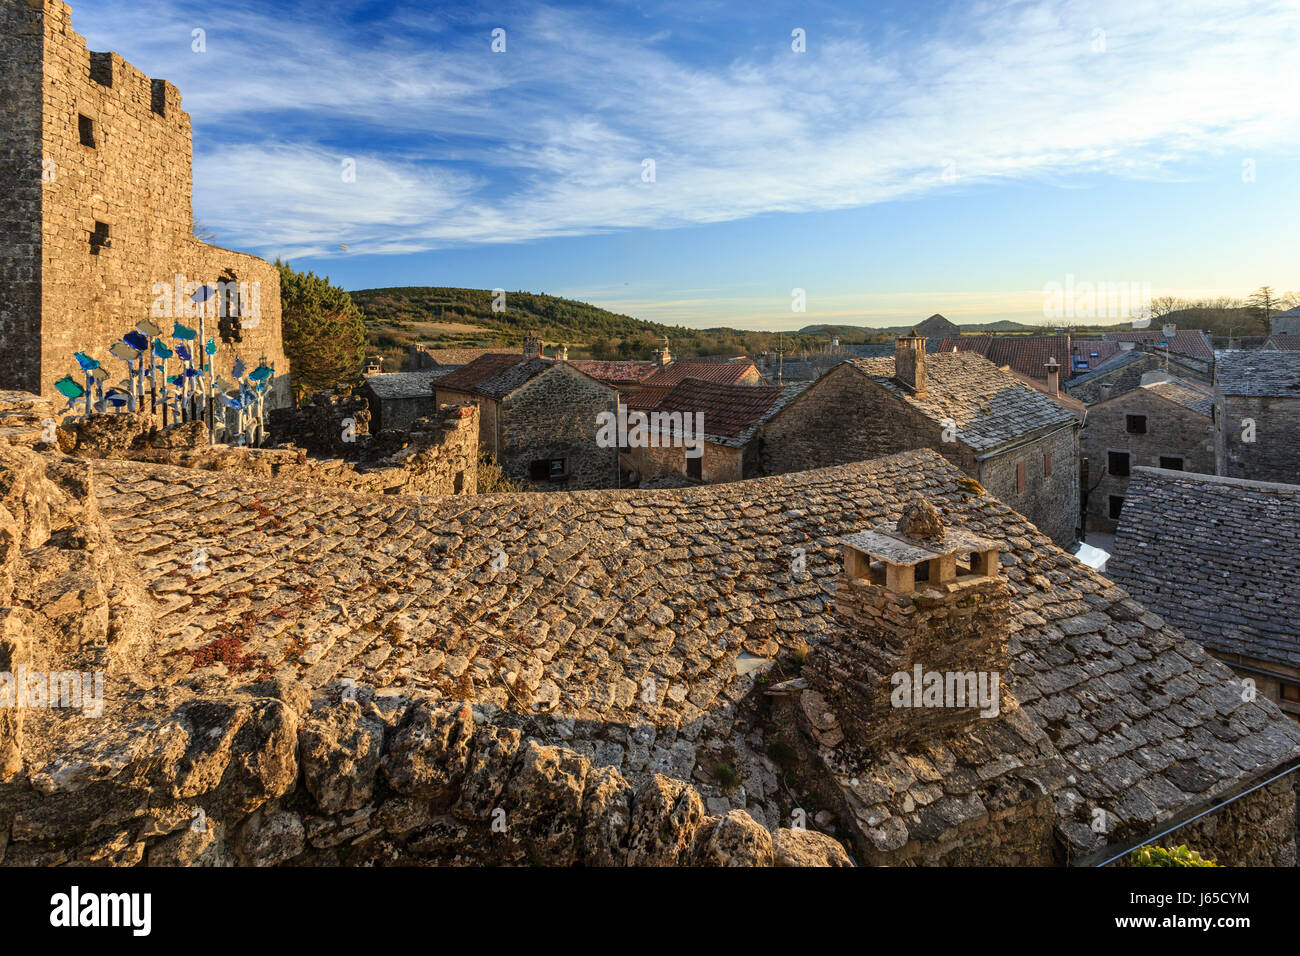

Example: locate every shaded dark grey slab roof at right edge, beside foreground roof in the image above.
[1106,467,1300,667]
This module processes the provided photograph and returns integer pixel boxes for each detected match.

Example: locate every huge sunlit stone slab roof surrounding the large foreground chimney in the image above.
[94,450,1300,855]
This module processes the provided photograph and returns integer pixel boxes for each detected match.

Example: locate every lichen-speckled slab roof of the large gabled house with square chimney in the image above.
[848,351,1078,453]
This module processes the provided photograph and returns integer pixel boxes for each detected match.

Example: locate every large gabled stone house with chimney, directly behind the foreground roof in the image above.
[759,336,1079,546]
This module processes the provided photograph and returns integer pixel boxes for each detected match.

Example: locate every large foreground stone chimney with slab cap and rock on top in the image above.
[805,498,1011,752]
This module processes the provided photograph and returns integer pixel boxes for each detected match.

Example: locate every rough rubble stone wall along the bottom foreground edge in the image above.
[0,682,852,866]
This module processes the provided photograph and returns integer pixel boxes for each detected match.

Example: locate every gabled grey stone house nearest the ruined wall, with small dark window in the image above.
[434,339,619,490]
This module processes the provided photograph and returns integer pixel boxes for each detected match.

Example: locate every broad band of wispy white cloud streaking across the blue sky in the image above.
[78,0,1300,256]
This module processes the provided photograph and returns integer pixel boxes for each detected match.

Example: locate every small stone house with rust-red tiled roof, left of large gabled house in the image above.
[620,378,805,484]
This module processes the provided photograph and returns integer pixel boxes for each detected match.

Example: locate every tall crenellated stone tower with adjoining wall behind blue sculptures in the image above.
[0,0,291,407]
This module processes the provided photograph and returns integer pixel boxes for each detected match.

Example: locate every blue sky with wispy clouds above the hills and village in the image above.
[72,0,1300,329]
